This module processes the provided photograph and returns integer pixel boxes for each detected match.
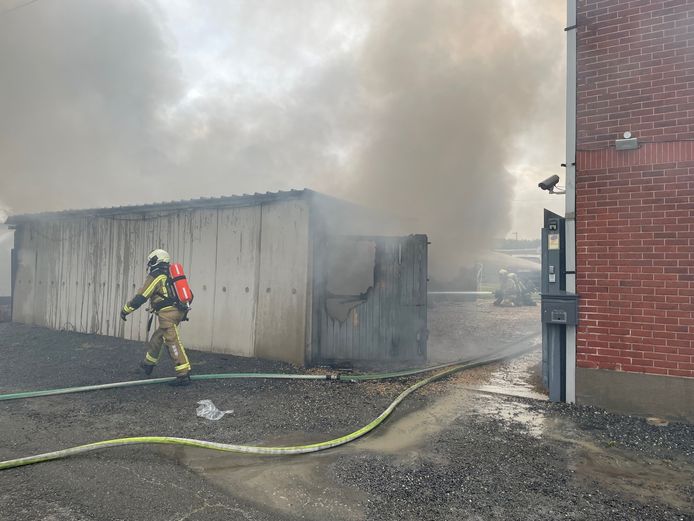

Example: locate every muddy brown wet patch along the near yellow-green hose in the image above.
[169,388,482,521]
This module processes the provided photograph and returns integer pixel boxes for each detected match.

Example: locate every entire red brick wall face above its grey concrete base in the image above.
[576,0,694,377]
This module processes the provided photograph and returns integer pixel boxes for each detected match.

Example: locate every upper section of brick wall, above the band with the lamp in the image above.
[576,0,694,148]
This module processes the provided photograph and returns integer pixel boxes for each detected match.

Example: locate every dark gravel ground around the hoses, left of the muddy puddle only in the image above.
[0,323,421,521]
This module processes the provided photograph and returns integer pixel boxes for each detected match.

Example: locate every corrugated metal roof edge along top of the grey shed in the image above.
[6,188,332,224]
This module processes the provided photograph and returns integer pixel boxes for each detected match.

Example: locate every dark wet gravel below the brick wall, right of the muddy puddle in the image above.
[335,394,694,520]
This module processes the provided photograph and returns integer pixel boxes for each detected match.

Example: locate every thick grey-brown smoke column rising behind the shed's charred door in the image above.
[353,0,561,276]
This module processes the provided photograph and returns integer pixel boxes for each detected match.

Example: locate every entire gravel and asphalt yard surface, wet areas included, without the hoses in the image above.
[0,303,694,521]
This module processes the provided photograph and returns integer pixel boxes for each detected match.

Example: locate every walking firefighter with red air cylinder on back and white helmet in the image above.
[120,249,193,386]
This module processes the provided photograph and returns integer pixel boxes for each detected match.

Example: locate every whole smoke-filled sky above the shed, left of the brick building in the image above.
[0,0,565,292]
